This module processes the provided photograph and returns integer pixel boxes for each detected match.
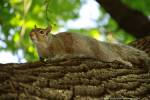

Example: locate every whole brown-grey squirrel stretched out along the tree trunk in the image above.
[30,27,150,66]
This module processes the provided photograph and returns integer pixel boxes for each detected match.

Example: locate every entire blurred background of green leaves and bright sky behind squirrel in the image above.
[0,0,150,63]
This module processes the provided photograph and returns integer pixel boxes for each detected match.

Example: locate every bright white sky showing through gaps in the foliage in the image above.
[0,0,101,63]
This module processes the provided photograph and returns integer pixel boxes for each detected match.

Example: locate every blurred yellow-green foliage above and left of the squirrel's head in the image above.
[0,0,80,61]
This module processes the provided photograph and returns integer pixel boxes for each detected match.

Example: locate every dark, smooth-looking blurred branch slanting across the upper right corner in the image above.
[96,0,150,38]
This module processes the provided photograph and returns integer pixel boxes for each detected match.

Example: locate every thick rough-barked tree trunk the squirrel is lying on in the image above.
[0,58,150,100]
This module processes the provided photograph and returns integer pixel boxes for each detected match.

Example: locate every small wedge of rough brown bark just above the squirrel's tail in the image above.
[129,36,150,57]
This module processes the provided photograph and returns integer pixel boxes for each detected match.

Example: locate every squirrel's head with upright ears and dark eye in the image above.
[30,26,52,43]
